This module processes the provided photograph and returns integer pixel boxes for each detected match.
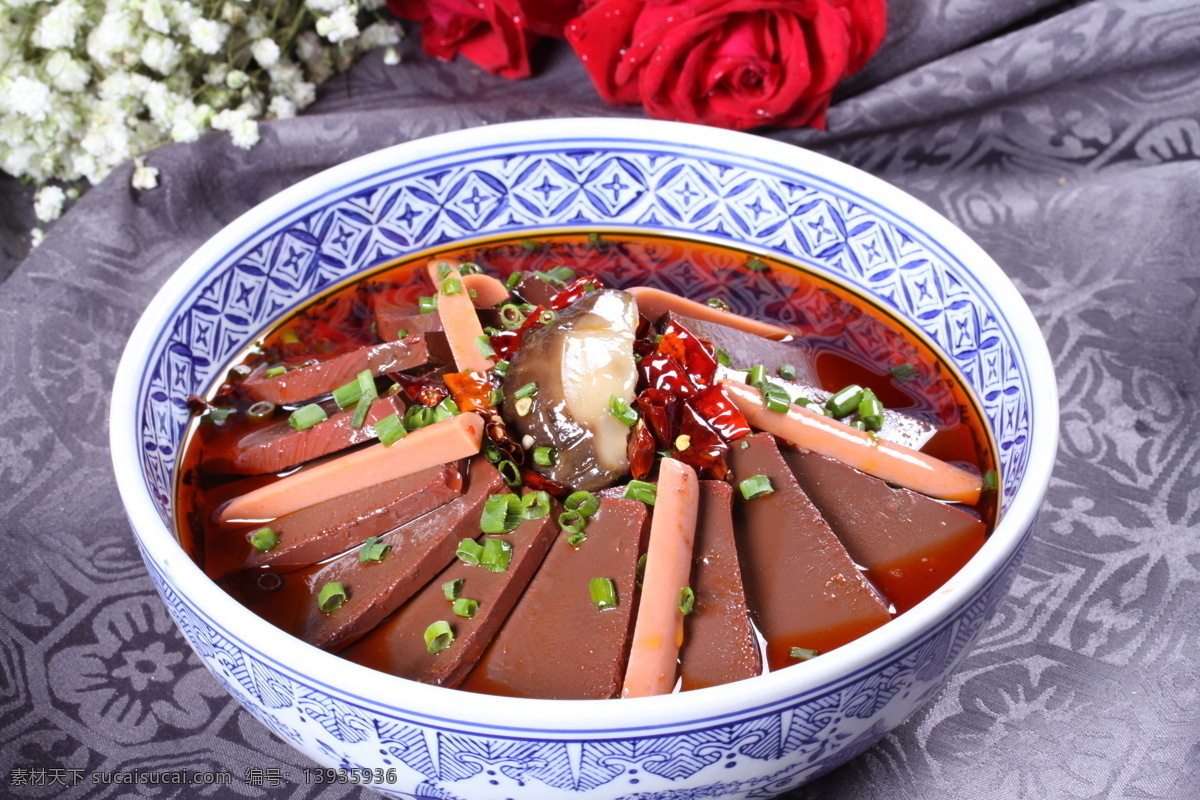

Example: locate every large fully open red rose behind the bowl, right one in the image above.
[566,0,887,130]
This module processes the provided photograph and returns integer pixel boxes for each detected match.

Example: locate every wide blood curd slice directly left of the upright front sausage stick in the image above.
[461,499,649,699]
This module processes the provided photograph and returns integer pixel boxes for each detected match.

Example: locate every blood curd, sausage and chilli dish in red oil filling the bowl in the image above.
[179,234,997,699]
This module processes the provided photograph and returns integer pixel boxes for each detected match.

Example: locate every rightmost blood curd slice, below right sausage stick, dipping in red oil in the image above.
[782,447,986,612]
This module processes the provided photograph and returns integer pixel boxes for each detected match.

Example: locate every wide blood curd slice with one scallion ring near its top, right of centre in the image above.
[730,433,892,669]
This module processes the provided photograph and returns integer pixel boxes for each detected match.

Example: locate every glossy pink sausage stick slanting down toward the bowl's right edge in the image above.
[721,380,983,504]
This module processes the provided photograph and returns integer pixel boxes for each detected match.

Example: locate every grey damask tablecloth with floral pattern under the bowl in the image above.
[0,0,1200,800]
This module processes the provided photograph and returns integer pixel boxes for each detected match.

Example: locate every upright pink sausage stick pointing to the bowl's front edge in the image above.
[620,458,700,697]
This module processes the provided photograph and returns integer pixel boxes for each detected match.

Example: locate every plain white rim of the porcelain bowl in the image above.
[109,118,1058,739]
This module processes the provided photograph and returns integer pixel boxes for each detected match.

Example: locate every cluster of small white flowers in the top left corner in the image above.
[0,0,402,242]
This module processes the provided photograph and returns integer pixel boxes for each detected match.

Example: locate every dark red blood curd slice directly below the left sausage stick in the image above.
[205,464,462,578]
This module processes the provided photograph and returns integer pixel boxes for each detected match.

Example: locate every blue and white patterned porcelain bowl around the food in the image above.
[112,119,1058,800]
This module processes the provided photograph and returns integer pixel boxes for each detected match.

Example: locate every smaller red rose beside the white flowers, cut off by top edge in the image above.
[388,0,577,78]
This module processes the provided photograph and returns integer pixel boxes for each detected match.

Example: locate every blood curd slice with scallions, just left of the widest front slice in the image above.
[341,517,557,687]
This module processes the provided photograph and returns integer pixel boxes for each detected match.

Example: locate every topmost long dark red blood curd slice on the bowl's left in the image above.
[242,335,430,405]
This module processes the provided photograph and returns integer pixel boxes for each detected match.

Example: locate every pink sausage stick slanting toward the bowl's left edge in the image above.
[221,413,484,523]
